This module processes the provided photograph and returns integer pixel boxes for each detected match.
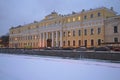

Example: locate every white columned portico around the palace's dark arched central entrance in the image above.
[39,30,63,47]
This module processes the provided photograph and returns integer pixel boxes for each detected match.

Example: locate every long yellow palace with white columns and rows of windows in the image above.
[9,7,120,48]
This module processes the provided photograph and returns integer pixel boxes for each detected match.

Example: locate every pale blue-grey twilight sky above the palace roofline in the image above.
[0,0,120,36]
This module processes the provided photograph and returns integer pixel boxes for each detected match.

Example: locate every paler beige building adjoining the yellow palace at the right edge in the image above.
[105,16,120,46]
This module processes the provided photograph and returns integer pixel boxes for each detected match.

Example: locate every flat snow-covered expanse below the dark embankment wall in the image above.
[0,54,120,80]
